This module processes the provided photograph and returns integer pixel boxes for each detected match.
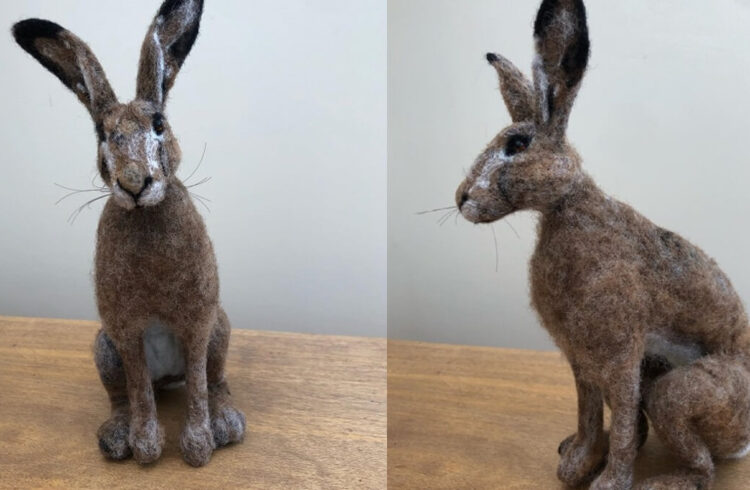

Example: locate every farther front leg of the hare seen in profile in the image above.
[557,368,608,487]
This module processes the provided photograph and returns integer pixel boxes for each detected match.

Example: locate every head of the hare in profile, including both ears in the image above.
[456,0,589,223]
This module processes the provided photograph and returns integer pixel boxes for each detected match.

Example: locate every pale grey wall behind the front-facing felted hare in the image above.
[0,0,386,336]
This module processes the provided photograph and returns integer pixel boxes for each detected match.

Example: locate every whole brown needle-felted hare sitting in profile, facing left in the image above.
[456,0,750,489]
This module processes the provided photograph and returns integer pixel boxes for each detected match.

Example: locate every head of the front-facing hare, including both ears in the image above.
[13,0,203,209]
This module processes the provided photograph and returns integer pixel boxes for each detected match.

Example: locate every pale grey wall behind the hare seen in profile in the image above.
[388,0,750,349]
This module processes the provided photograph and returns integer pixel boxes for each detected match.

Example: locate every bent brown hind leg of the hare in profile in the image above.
[638,356,750,489]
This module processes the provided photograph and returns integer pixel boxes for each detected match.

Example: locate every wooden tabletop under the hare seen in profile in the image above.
[388,341,750,489]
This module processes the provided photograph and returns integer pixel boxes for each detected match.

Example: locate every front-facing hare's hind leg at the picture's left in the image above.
[94,330,132,460]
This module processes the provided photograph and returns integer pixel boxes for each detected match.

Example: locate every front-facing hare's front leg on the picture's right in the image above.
[180,325,216,466]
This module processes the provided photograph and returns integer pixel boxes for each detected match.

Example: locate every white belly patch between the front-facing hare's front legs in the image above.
[143,319,185,381]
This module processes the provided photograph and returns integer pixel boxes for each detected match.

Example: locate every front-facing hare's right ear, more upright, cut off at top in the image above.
[136,0,203,108]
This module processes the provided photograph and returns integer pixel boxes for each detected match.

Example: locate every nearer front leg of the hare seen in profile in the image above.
[591,364,641,490]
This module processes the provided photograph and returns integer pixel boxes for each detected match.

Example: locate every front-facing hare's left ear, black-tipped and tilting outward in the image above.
[13,19,117,123]
